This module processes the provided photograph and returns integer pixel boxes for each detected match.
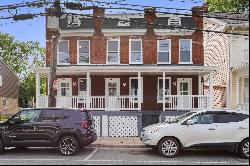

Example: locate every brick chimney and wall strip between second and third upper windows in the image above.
[90,7,106,64]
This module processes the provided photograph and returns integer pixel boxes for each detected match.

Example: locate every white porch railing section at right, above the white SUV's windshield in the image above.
[165,95,210,110]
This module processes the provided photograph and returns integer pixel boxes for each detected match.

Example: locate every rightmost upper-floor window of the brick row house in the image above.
[179,39,193,64]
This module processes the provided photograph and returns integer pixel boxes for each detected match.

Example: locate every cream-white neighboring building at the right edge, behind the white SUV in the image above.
[204,13,249,110]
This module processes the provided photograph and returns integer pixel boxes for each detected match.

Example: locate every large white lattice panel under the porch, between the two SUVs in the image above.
[109,116,138,137]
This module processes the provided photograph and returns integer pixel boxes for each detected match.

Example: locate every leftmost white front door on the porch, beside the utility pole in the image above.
[57,78,72,108]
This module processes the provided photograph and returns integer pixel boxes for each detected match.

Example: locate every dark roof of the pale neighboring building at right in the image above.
[207,13,249,24]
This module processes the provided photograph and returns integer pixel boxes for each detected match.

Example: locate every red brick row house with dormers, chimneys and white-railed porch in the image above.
[34,4,216,111]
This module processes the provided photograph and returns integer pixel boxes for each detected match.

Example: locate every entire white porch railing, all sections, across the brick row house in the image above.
[37,95,210,111]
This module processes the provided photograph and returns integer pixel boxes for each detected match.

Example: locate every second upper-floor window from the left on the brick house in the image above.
[78,40,90,64]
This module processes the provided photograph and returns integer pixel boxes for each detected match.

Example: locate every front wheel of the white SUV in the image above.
[158,137,180,158]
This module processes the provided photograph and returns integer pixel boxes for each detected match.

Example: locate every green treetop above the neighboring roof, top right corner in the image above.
[206,0,249,13]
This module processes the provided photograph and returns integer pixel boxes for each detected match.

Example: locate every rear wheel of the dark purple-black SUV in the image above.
[58,136,79,156]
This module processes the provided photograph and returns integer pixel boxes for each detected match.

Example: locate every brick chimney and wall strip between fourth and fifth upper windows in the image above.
[143,8,157,64]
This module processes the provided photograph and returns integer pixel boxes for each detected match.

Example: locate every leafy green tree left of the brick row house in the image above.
[0,33,45,107]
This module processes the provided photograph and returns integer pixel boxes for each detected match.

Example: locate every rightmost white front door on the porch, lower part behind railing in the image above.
[177,78,192,108]
